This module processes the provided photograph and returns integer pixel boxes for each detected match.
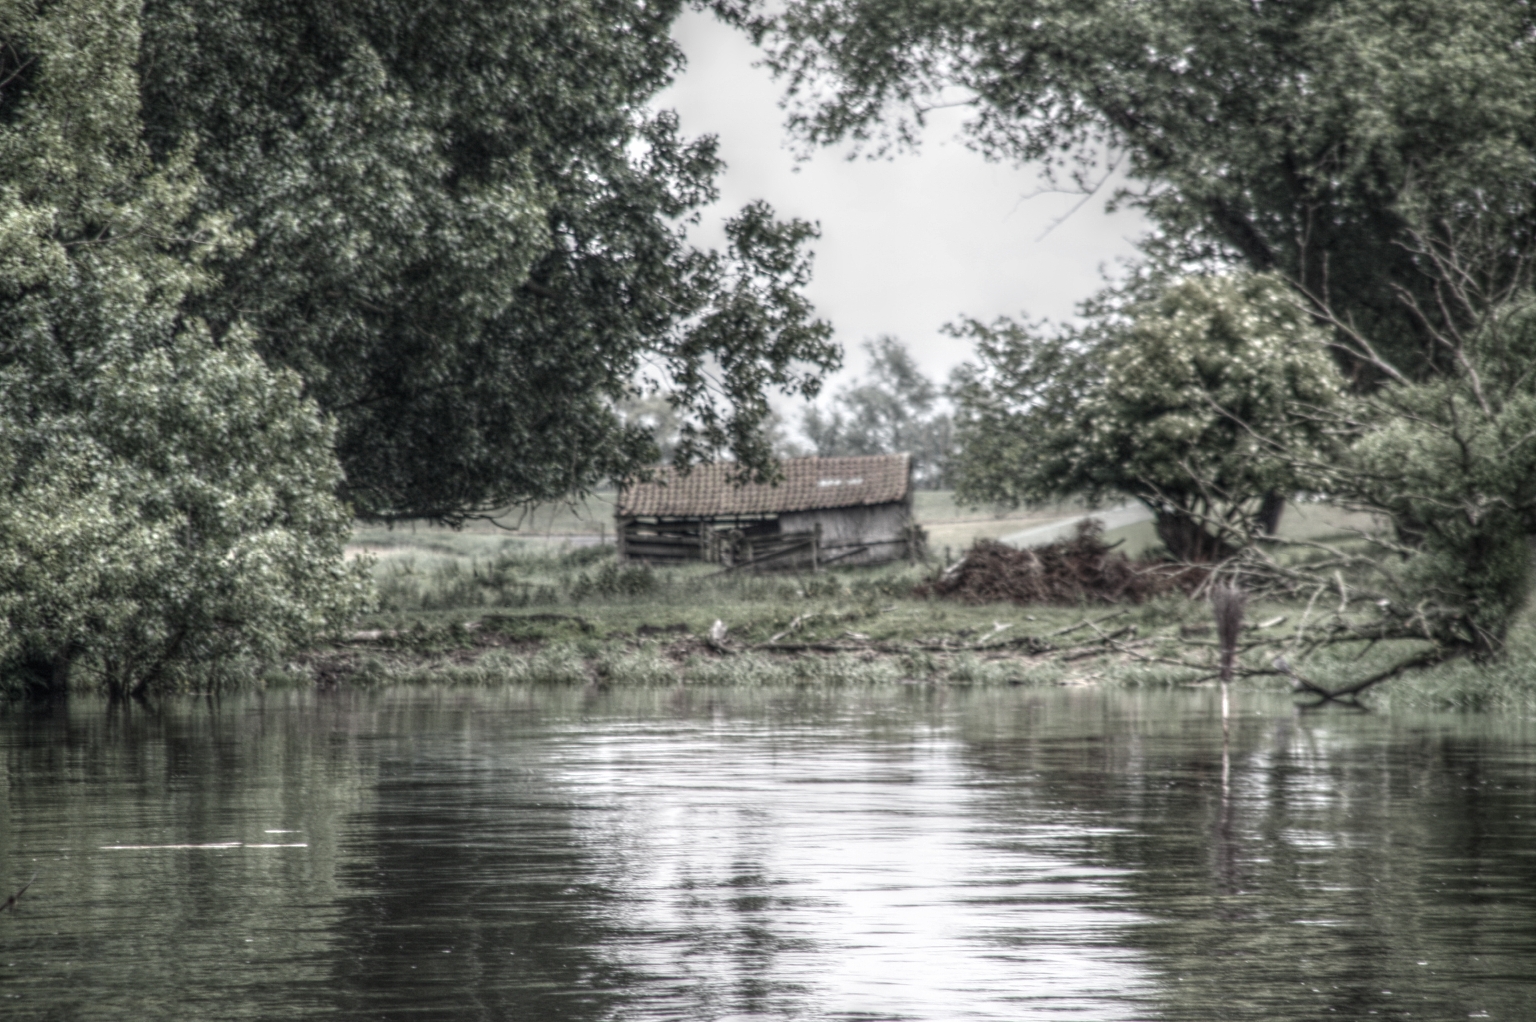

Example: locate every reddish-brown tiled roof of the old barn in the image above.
[617,455,911,518]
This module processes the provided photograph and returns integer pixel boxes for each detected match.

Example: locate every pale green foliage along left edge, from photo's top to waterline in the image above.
[0,0,367,693]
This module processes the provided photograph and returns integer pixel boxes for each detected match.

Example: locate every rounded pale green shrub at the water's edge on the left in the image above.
[0,333,370,695]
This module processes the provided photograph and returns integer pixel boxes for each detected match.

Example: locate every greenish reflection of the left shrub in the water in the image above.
[0,698,367,1020]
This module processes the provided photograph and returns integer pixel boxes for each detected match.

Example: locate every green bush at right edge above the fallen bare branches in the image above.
[1327,298,1536,659]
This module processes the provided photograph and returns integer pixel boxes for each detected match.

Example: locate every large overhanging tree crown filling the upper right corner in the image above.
[728,0,1536,381]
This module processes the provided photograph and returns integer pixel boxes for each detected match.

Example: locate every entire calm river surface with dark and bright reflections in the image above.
[0,690,1536,1022]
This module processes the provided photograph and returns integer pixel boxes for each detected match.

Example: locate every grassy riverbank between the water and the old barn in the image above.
[266,498,1536,710]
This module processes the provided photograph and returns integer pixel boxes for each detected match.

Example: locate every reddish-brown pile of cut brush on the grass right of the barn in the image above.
[914,518,1203,604]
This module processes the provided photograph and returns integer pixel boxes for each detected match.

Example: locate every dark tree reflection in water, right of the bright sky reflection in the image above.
[965,696,1536,1020]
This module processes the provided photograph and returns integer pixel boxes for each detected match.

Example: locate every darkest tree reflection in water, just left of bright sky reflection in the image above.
[324,712,631,1022]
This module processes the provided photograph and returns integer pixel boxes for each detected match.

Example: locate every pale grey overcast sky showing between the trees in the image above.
[657,11,1141,402]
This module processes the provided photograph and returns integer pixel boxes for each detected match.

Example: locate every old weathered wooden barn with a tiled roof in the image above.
[614,455,923,570]
